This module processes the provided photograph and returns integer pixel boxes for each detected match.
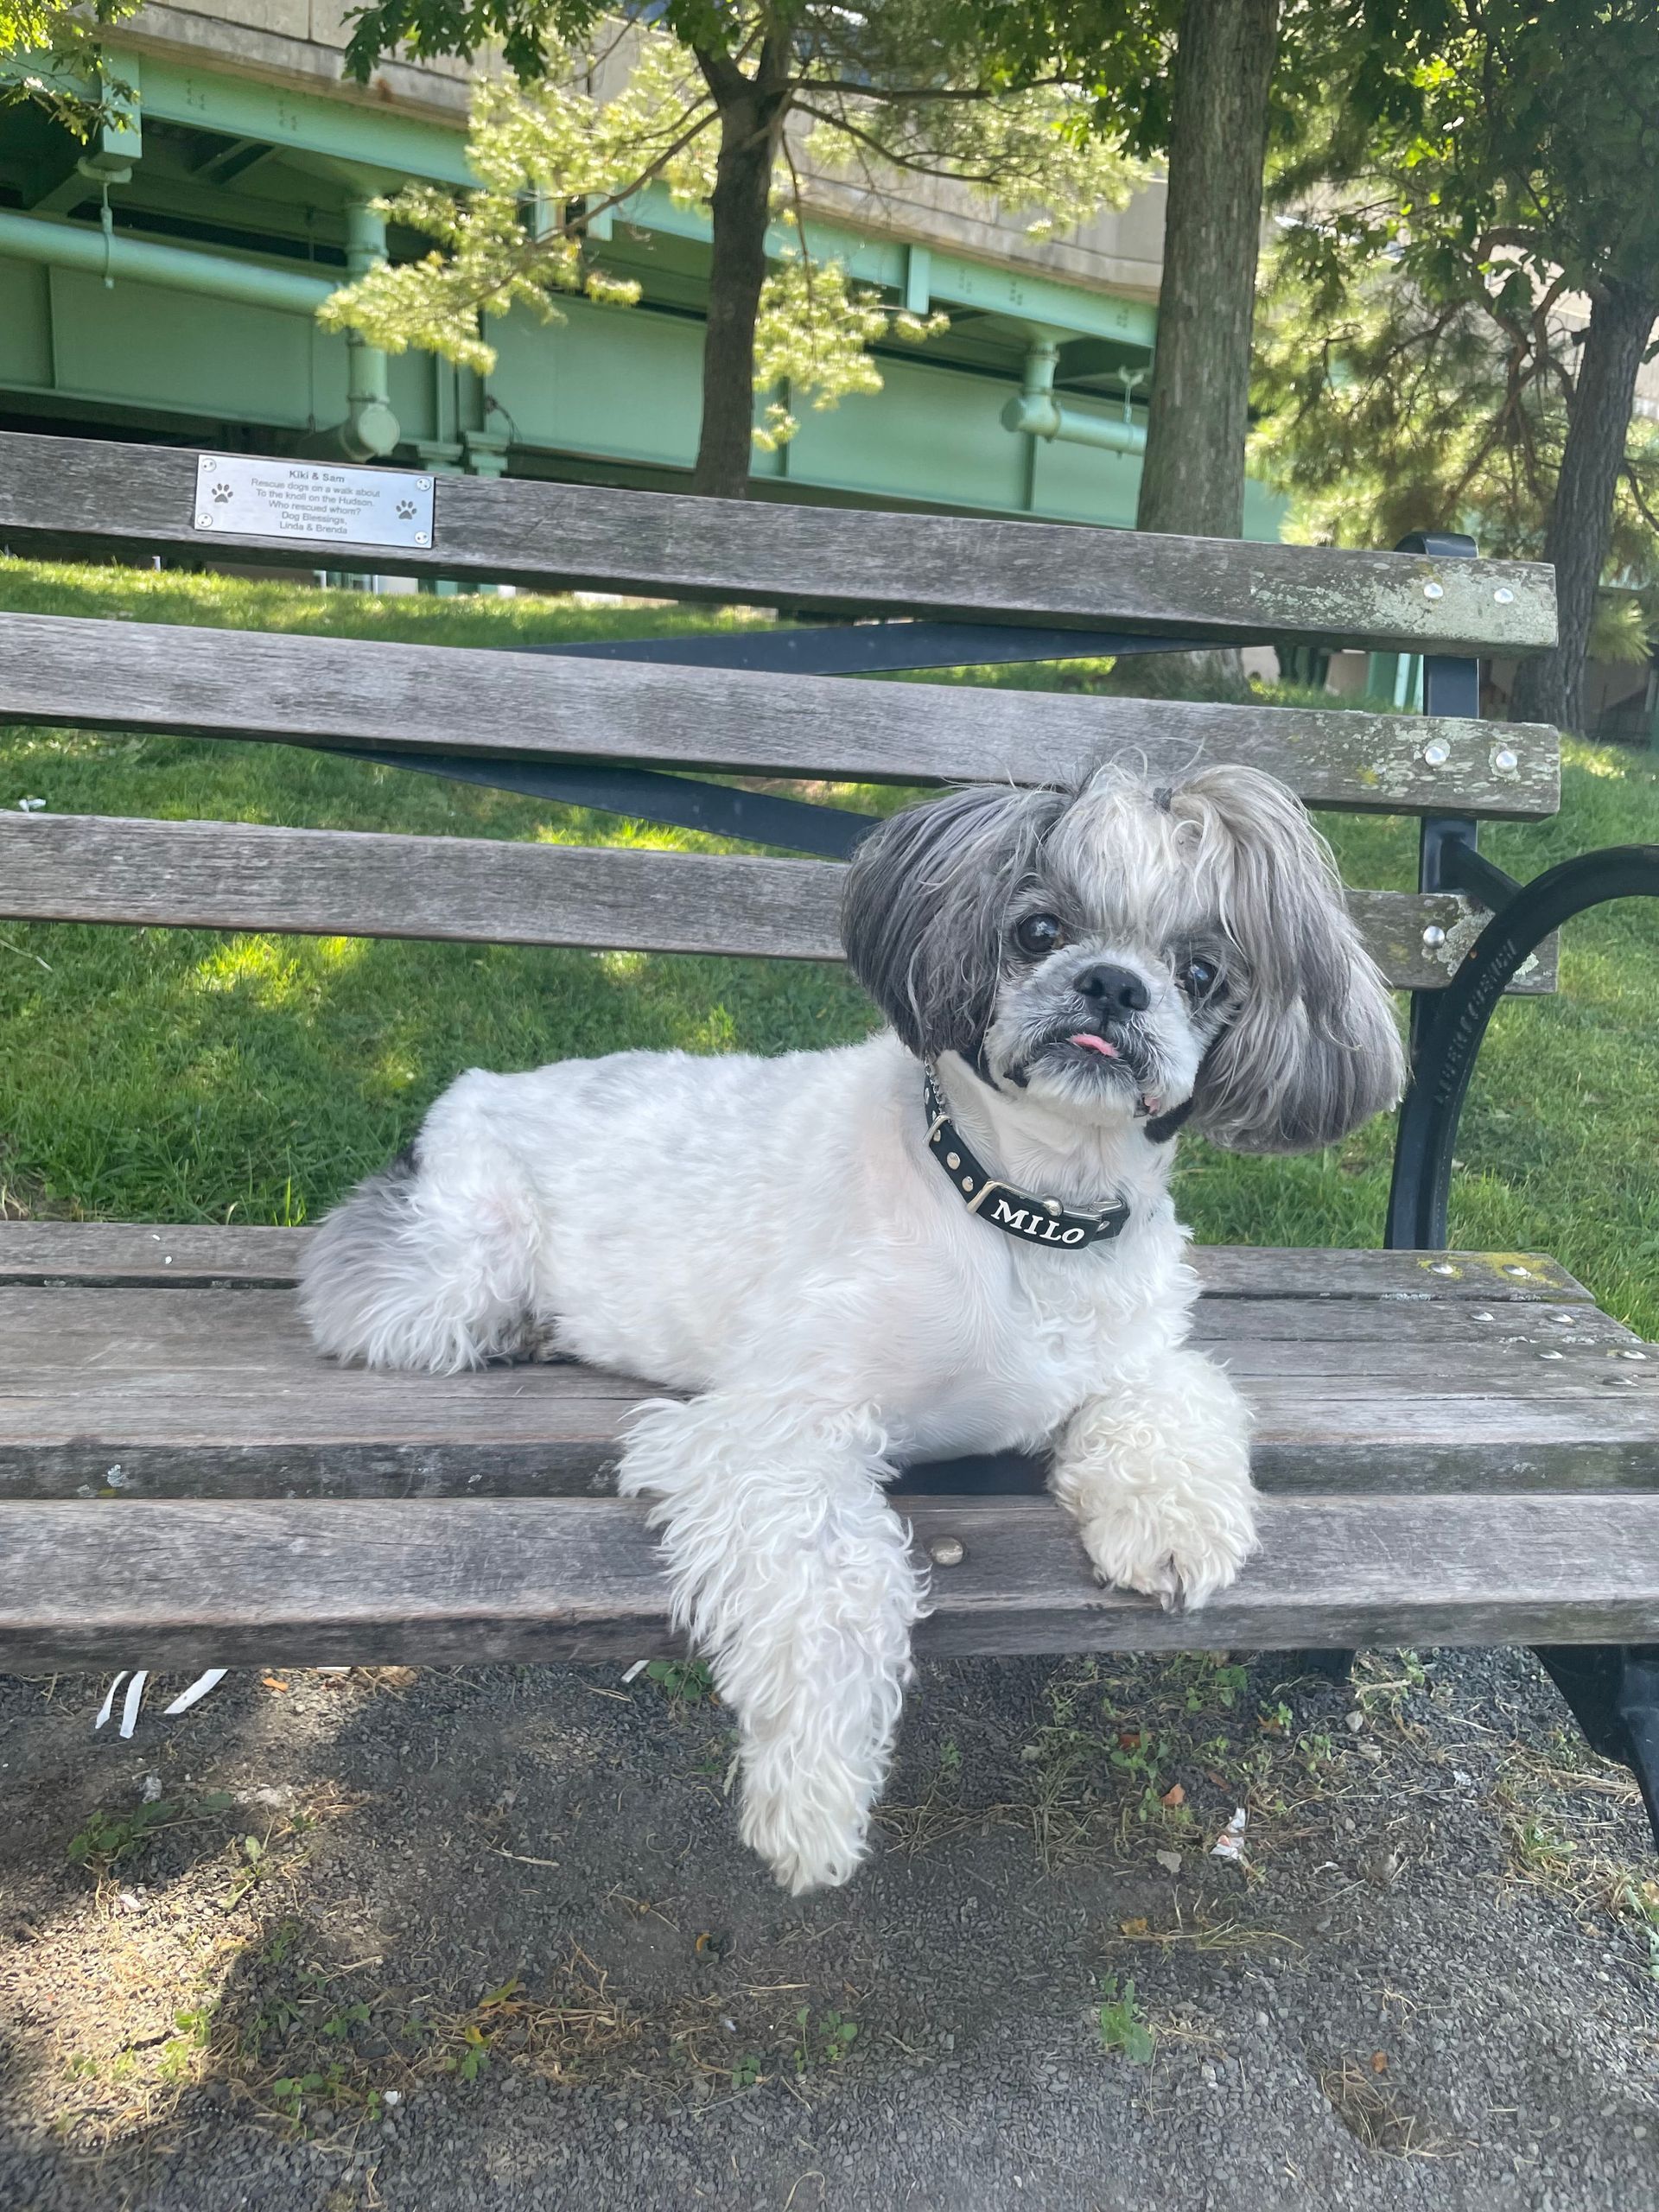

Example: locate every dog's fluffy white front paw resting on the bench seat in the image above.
[1048,1350,1256,1611]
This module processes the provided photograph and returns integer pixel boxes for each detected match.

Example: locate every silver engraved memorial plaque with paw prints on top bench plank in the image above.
[194,454,431,546]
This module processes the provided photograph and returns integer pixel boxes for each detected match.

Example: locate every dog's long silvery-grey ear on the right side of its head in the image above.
[1170,767,1405,1153]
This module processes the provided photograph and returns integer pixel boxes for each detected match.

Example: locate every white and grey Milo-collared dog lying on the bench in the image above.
[303,767,1402,1891]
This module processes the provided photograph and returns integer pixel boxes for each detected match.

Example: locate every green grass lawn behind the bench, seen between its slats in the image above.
[0,560,1659,1334]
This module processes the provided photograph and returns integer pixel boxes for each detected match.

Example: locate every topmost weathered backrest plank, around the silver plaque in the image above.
[0,434,1555,655]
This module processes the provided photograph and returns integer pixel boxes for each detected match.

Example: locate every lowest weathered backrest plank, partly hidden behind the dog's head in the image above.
[0,814,1555,993]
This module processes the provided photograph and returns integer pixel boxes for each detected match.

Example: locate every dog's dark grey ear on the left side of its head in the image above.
[841,785,1068,1059]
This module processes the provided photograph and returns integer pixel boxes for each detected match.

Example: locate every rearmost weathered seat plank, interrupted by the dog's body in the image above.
[0,1221,1595,1325]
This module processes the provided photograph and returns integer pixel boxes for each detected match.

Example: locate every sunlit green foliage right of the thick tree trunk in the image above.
[1255,0,1659,601]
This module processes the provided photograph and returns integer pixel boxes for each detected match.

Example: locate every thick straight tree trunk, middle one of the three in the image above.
[1137,0,1279,537]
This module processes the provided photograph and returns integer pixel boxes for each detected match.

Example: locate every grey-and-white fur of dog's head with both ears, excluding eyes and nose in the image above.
[842,766,1405,1153]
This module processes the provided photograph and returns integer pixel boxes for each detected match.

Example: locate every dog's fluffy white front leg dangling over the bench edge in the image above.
[620,1391,925,1896]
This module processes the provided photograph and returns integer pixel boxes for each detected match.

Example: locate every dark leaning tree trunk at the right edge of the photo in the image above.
[1510,283,1659,730]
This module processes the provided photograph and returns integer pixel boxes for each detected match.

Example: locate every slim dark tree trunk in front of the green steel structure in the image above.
[692,55,787,500]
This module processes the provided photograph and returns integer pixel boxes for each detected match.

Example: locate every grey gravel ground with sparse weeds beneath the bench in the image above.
[0,1652,1659,2212]
